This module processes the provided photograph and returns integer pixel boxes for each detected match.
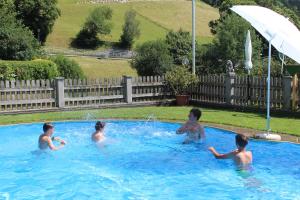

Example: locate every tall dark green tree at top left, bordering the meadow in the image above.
[14,0,60,44]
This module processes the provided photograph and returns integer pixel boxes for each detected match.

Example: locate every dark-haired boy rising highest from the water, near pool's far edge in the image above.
[176,108,205,144]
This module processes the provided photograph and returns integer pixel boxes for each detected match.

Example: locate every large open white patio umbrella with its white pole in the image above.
[231,6,300,132]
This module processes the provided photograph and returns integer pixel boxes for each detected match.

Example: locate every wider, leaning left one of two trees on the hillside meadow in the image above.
[72,6,112,48]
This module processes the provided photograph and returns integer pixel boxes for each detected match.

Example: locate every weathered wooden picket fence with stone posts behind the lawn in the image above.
[0,74,300,113]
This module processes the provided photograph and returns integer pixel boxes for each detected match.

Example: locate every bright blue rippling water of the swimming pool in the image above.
[0,121,300,200]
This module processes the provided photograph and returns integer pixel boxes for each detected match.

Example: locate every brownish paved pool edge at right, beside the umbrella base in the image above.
[202,123,300,144]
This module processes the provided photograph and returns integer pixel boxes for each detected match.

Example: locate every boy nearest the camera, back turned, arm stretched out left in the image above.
[209,134,252,168]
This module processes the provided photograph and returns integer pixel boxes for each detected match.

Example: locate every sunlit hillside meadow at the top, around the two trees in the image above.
[46,0,219,50]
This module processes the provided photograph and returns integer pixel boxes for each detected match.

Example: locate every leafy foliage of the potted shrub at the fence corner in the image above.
[166,66,198,95]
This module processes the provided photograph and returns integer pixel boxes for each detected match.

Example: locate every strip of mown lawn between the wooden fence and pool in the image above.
[0,107,300,136]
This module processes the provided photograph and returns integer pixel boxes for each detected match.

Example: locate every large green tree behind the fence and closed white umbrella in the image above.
[196,15,261,74]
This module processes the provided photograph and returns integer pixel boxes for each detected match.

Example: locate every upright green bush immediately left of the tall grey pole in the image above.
[166,29,192,65]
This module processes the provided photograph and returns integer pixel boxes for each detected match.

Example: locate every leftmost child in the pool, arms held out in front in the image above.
[39,123,66,151]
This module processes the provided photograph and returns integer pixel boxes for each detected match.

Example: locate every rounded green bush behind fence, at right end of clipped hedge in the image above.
[50,55,85,79]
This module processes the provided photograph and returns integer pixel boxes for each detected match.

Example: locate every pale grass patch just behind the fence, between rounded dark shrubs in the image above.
[71,57,137,79]
